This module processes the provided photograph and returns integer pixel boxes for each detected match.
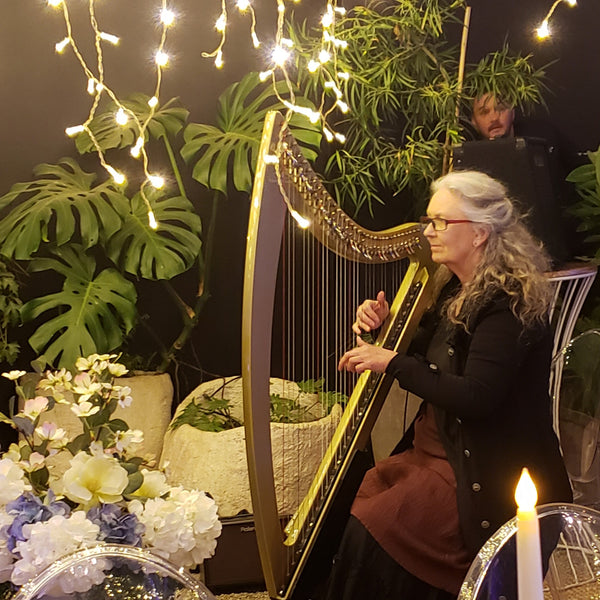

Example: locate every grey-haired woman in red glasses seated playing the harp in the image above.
[336,171,572,600]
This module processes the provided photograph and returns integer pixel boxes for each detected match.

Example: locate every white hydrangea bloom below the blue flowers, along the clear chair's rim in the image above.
[11,511,100,585]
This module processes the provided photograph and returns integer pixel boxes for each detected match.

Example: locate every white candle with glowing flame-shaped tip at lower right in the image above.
[515,469,544,600]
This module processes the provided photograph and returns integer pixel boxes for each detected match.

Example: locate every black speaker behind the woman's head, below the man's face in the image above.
[454,137,568,263]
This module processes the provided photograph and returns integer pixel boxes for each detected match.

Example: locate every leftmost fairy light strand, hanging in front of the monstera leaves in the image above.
[48,0,175,229]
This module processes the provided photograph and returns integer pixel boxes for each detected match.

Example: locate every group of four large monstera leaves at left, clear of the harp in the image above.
[0,94,202,367]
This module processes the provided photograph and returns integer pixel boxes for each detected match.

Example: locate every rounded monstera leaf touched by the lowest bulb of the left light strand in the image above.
[107,194,202,279]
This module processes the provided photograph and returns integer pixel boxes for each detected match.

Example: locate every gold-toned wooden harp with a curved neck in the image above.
[242,112,434,599]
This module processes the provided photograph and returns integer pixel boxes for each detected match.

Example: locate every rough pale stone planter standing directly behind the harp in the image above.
[161,378,342,517]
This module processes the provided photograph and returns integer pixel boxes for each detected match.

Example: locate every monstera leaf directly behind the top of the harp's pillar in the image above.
[181,73,321,194]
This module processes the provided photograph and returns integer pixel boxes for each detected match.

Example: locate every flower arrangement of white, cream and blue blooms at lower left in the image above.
[0,354,221,591]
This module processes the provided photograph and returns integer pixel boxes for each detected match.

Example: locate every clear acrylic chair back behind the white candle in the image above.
[458,503,600,600]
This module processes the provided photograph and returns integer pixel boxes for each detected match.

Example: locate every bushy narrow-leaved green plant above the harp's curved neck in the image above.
[289,0,544,217]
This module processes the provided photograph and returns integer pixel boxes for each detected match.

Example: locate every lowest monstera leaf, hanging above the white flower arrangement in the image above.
[21,244,137,367]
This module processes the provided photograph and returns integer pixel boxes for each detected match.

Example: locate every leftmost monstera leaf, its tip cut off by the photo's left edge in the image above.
[0,158,129,259]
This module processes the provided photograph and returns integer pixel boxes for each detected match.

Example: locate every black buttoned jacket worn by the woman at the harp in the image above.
[387,284,572,555]
